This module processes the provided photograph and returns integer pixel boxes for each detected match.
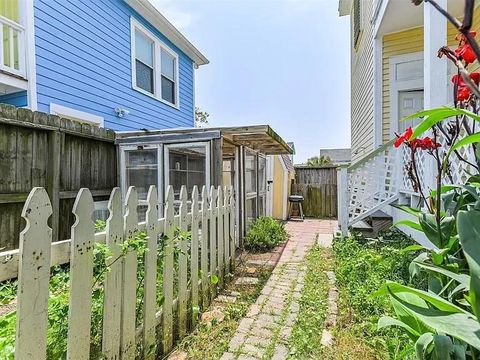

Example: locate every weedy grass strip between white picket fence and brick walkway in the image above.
[172,268,272,360]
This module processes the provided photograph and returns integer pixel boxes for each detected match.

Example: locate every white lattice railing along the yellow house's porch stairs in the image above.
[338,123,475,234]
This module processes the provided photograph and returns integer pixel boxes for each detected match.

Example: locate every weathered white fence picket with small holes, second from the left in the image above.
[67,188,95,360]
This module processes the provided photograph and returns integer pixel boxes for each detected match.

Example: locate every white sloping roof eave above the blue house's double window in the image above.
[124,0,210,66]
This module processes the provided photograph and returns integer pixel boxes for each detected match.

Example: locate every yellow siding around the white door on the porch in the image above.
[382,27,423,142]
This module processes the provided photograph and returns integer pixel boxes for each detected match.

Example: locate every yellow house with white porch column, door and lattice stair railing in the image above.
[339,0,480,239]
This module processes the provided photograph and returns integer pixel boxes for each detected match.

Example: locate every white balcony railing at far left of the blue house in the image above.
[0,16,26,78]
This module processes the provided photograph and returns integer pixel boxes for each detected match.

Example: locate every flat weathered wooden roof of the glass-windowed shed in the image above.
[116,125,293,155]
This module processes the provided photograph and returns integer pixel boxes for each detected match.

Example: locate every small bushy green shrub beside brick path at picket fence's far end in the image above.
[245,216,287,252]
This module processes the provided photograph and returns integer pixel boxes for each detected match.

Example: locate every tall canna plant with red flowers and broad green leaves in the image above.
[375,0,480,360]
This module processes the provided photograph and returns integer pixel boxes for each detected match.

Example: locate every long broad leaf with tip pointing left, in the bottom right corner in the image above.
[390,293,480,349]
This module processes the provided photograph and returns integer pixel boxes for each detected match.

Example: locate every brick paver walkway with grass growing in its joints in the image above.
[221,220,336,360]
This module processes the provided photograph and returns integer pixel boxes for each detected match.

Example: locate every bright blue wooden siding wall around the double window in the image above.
[35,0,194,130]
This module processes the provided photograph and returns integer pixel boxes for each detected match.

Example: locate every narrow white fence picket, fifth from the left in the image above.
[143,185,158,360]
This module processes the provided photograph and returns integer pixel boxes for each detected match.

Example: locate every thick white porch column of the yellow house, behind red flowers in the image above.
[423,0,449,190]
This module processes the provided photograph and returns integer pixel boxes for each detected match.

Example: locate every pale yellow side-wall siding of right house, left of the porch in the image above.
[350,1,374,161]
